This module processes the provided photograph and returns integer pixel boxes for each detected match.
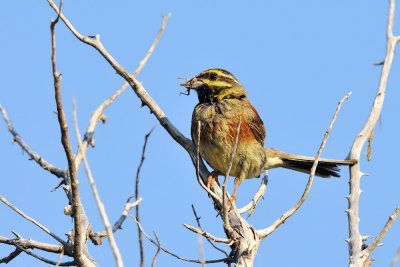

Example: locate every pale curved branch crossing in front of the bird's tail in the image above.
[258,92,351,239]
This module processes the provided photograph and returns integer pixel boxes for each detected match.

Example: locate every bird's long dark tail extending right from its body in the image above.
[265,148,357,178]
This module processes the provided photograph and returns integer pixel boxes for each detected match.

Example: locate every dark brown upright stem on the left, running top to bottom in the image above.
[50,0,84,266]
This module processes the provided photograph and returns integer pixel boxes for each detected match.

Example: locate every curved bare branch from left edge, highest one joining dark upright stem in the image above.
[0,105,65,178]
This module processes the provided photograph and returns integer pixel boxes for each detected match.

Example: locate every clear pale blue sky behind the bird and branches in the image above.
[0,0,400,267]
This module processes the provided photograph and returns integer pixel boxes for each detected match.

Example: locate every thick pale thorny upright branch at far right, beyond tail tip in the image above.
[346,0,400,266]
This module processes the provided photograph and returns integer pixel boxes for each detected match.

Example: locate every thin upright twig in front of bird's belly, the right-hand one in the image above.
[222,117,242,237]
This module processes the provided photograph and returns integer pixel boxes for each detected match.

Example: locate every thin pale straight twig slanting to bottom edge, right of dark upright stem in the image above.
[72,98,124,267]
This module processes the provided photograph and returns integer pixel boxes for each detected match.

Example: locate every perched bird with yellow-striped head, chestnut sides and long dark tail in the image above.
[180,68,356,201]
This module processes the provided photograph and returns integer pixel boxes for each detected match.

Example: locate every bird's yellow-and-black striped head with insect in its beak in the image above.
[181,69,247,104]
